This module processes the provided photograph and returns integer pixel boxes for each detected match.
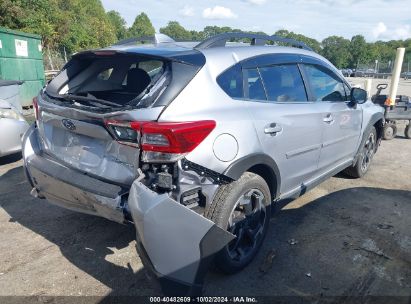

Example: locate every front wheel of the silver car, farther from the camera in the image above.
[344,127,378,178]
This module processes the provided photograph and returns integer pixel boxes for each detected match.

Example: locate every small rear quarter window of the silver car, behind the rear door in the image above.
[217,64,244,98]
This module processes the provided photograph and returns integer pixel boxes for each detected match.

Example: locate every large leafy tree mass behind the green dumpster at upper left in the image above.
[0,0,116,53]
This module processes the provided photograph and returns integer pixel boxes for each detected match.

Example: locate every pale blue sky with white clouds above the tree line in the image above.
[102,0,411,41]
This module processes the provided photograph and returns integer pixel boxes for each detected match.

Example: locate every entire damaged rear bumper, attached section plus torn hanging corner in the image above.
[23,126,235,296]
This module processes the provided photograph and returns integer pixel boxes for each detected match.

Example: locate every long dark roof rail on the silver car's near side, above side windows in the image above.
[195,33,312,51]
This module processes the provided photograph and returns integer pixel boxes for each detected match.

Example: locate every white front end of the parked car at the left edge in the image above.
[0,99,29,157]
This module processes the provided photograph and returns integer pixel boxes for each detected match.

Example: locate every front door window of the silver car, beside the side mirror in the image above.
[305,65,347,101]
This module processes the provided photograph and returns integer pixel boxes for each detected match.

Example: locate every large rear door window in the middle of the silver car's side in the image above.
[259,64,307,102]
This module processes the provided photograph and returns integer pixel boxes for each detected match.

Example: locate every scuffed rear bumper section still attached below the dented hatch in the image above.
[23,126,128,223]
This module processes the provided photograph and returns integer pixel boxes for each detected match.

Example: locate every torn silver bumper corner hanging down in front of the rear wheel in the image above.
[128,179,235,295]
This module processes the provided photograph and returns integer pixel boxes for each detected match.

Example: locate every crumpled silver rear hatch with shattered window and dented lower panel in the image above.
[35,47,205,185]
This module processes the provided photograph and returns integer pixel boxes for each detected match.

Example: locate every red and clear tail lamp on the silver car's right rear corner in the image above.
[106,120,216,163]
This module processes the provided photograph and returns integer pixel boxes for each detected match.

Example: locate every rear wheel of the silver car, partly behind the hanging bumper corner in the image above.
[205,172,271,274]
